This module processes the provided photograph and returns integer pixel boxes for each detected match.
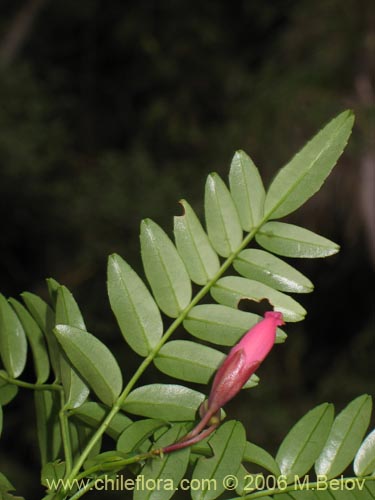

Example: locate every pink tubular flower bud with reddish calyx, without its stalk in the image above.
[206,311,284,416]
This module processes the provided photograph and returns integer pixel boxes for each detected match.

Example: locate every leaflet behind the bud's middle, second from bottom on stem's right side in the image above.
[154,340,259,388]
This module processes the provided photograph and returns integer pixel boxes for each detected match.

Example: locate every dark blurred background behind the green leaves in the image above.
[0,0,375,498]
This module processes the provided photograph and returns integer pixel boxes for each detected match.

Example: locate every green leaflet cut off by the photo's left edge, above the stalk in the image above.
[0,294,27,378]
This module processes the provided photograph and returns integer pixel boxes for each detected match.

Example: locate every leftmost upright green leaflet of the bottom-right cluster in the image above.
[276,403,334,483]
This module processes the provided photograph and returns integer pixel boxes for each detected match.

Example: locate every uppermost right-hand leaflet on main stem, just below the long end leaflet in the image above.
[255,222,340,259]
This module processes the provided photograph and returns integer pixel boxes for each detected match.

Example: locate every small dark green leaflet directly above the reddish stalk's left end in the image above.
[116,418,169,453]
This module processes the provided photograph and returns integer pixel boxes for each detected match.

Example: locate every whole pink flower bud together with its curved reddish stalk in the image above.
[155,311,284,454]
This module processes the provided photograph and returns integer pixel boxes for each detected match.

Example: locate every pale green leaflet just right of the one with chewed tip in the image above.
[204,173,242,257]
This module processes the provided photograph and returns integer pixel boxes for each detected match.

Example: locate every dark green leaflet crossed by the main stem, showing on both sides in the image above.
[69,401,133,440]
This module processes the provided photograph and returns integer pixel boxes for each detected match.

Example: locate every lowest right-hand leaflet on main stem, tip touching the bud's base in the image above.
[123,384,205,421]
